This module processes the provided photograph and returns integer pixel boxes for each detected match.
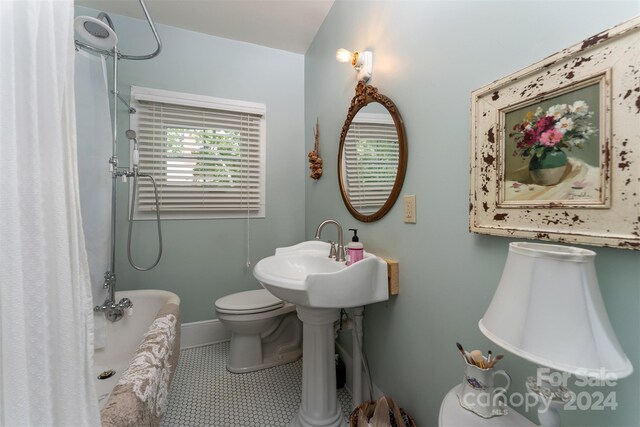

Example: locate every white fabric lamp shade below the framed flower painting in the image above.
[479,242,633,379]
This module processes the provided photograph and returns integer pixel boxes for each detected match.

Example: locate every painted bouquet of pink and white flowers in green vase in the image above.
[509,100,596,185]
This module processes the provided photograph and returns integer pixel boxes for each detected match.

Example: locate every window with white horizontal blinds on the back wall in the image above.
[131,86,266,219]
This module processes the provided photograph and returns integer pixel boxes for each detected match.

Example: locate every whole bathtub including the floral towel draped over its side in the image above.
[93,290,180,427]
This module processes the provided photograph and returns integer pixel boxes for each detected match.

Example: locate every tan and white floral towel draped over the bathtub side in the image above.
[101,304,180,427]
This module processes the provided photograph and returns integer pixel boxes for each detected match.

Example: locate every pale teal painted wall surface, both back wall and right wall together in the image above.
[76,0,640,426]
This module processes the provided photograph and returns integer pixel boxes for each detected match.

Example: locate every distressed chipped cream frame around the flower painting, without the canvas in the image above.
[469,17,640,250]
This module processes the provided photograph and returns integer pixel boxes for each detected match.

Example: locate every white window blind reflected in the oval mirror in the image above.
[344,114,399,213]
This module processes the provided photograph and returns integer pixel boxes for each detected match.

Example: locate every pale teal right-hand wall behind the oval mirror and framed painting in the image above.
[304,0,640,426]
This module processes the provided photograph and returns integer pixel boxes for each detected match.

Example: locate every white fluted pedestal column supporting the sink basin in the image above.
[291,306,347,427]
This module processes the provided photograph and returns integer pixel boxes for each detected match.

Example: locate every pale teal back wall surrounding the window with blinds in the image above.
[76,4,306,322]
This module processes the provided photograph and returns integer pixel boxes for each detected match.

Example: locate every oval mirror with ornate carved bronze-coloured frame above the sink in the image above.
[338,82,407,222]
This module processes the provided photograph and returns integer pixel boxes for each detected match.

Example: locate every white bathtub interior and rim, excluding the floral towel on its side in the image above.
[93,289,180,409]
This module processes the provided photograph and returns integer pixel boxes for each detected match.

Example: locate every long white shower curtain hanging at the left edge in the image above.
[0,0,99,427]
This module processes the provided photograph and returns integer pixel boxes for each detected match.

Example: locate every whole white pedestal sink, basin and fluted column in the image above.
[253,240,389,427]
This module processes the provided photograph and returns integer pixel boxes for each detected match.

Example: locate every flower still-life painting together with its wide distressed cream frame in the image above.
[470,17,640,250]
